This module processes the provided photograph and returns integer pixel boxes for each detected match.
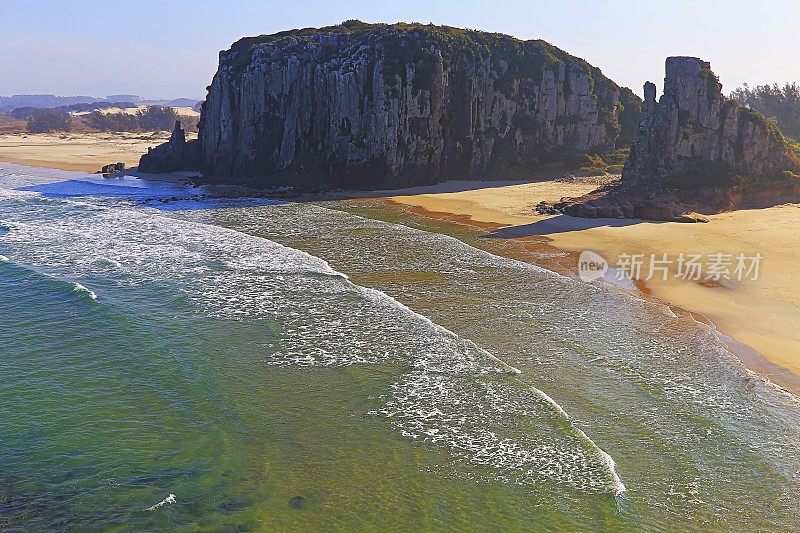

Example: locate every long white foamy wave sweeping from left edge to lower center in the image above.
[4,193,623,493]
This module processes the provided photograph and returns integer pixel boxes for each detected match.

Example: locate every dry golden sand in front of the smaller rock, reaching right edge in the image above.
[549,205,800,374]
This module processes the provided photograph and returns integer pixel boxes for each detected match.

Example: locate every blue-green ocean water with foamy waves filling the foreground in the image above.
[0,164,800,531]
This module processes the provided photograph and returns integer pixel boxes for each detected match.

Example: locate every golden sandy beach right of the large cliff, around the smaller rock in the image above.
[380,181,800,374]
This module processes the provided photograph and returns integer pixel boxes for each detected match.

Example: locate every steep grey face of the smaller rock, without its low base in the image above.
[622,57,798,186]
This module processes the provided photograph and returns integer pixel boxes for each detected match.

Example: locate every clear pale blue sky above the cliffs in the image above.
[0,0,800,98]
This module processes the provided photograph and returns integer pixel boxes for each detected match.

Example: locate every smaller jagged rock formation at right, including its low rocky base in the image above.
[548,57,800,218]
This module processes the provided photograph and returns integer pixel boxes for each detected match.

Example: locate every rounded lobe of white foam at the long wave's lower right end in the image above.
[374,371,625,496]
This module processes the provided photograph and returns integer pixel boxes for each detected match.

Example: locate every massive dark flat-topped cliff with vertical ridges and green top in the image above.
[148,21,640,187]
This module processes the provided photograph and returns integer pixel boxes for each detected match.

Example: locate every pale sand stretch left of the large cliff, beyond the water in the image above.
[0,132,182,172]
